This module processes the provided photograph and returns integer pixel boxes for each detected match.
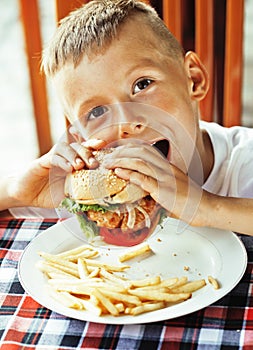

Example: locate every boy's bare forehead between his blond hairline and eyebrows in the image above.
[54,20,180,121]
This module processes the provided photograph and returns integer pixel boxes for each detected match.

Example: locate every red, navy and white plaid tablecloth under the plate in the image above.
[0,219,253,350]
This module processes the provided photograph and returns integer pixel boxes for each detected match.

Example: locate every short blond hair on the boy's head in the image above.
[42,0,183,76]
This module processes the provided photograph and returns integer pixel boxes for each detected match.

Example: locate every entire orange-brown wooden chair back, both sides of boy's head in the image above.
[19,0,244,154]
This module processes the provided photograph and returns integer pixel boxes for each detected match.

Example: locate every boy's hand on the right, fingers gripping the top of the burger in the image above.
[105,144,202,224]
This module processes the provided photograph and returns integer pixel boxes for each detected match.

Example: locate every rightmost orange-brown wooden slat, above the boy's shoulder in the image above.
[223,0,244,127]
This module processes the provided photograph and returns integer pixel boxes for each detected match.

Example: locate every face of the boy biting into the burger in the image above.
[53,17,206,170]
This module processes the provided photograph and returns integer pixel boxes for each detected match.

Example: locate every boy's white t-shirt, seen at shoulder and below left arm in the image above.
[10,121,253,218]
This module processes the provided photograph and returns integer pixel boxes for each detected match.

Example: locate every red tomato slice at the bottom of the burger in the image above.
[99,227,150,247]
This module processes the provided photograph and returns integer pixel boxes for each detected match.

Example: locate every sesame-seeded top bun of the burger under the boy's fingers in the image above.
[64,148,147,204]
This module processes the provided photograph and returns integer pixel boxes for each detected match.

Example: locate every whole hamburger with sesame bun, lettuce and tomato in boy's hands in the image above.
[61,149,164,246]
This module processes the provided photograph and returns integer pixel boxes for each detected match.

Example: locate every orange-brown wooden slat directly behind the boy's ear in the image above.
[195,0,215,121]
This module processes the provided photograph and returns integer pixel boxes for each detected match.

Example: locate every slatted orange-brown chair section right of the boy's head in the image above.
[162,0,244,127]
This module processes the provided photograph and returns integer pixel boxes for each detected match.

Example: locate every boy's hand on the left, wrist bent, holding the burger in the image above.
[6,140,104,209]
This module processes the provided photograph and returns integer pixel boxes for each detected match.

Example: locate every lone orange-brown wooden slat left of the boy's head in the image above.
[19,0,52,155]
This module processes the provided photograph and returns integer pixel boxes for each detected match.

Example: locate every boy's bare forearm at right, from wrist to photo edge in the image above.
[198,192,253,235]
